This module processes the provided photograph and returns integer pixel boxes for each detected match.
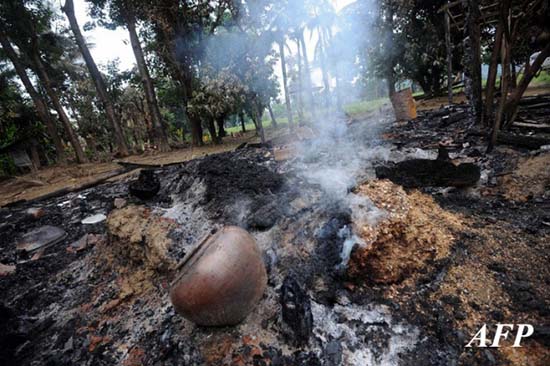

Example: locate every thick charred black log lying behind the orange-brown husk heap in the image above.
[375,159,481,188]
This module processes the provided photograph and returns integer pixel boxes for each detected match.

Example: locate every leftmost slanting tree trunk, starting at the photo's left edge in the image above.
[0,31,67,164]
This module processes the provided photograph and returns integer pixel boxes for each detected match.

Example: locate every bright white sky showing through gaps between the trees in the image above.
[66,0,355,74]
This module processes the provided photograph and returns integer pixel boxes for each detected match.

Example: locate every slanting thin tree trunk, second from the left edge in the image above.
[30,47,88,163]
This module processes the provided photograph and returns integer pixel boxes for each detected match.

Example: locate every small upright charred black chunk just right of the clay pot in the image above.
[280,274,313,345]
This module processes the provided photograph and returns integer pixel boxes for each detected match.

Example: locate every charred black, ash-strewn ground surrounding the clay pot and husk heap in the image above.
[0,106,550,365]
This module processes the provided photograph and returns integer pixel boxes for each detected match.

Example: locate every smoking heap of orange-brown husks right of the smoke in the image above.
[347,180,462,284]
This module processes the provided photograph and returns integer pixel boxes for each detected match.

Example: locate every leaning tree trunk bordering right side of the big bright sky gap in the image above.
[124,9,170,152]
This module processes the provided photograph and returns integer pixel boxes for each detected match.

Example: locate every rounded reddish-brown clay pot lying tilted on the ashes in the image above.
[170,226,267,326]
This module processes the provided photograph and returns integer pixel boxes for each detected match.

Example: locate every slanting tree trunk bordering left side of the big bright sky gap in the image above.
[62,0,128,156]
